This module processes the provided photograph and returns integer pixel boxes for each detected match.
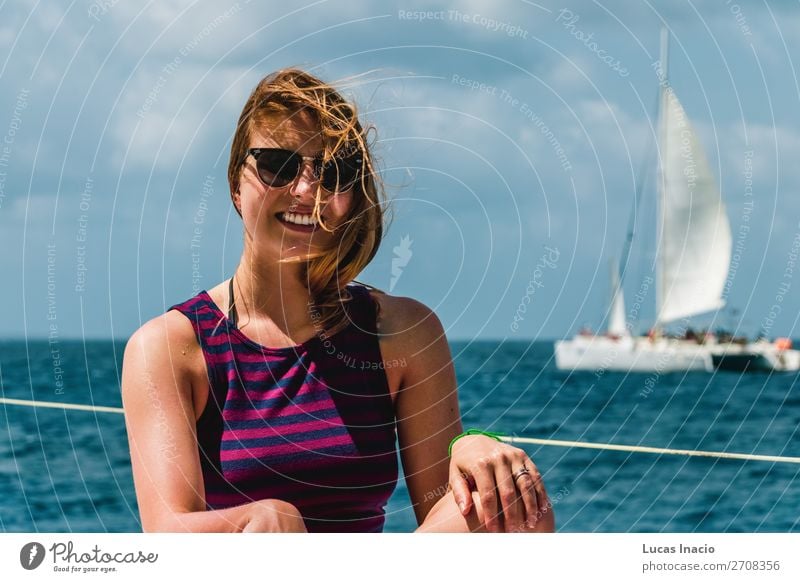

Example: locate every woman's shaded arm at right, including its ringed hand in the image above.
[379,295,553,532]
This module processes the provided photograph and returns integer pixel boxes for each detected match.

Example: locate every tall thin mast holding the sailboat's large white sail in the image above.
[653,26,669,336]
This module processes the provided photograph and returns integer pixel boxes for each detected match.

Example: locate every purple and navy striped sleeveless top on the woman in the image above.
[170,284,398,532]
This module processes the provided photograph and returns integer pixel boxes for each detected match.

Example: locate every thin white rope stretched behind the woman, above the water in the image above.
[0,398,800,464]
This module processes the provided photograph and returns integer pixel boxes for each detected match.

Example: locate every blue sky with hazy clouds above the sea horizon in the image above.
[0,0,800,340]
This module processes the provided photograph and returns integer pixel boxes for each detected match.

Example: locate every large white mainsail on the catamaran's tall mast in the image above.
[658,87,731,323]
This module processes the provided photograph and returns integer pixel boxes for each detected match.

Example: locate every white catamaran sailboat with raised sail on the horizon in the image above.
[555,29,800,373]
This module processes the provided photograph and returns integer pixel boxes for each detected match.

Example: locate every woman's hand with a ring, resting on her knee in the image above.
[449,435,553,532]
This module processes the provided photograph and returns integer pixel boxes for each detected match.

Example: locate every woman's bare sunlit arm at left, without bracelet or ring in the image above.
[122,311,305,532]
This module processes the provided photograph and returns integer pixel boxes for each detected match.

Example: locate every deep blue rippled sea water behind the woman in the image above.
[0,341,800,532]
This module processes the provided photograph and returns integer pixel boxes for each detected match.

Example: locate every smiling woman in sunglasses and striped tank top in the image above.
[122,69,553,532]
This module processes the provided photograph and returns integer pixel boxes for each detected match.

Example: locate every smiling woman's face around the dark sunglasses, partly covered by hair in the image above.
[234,112,353,259]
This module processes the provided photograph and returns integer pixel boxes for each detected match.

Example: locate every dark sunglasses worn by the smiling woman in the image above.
[247,148,364,192]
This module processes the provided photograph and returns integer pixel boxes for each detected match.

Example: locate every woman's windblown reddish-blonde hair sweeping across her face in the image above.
[228,69,386,335]
